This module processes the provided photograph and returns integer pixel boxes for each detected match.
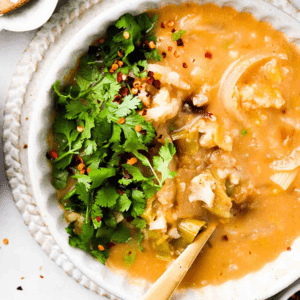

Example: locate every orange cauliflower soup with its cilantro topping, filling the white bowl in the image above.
[48,3,300,288]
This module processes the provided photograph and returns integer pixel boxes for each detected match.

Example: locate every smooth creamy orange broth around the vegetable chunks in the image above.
[107,3,300,288]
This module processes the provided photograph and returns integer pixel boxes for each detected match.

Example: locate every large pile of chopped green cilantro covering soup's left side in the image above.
[52,13,176,264]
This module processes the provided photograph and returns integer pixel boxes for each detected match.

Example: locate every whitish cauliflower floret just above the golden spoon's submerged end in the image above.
[189,173,216,208]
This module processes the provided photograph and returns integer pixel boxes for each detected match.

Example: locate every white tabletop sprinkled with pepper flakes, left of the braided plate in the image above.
[0,0,300,300]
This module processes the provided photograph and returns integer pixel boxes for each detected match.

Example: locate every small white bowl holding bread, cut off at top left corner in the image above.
[0,0,58,31]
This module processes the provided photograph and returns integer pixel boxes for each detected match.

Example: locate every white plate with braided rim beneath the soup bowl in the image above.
[4,0,300,299]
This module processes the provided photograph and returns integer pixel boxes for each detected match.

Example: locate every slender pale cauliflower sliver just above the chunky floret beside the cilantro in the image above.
[148,64,191,90]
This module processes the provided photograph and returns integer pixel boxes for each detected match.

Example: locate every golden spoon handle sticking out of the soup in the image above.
[142,223,217,300]
